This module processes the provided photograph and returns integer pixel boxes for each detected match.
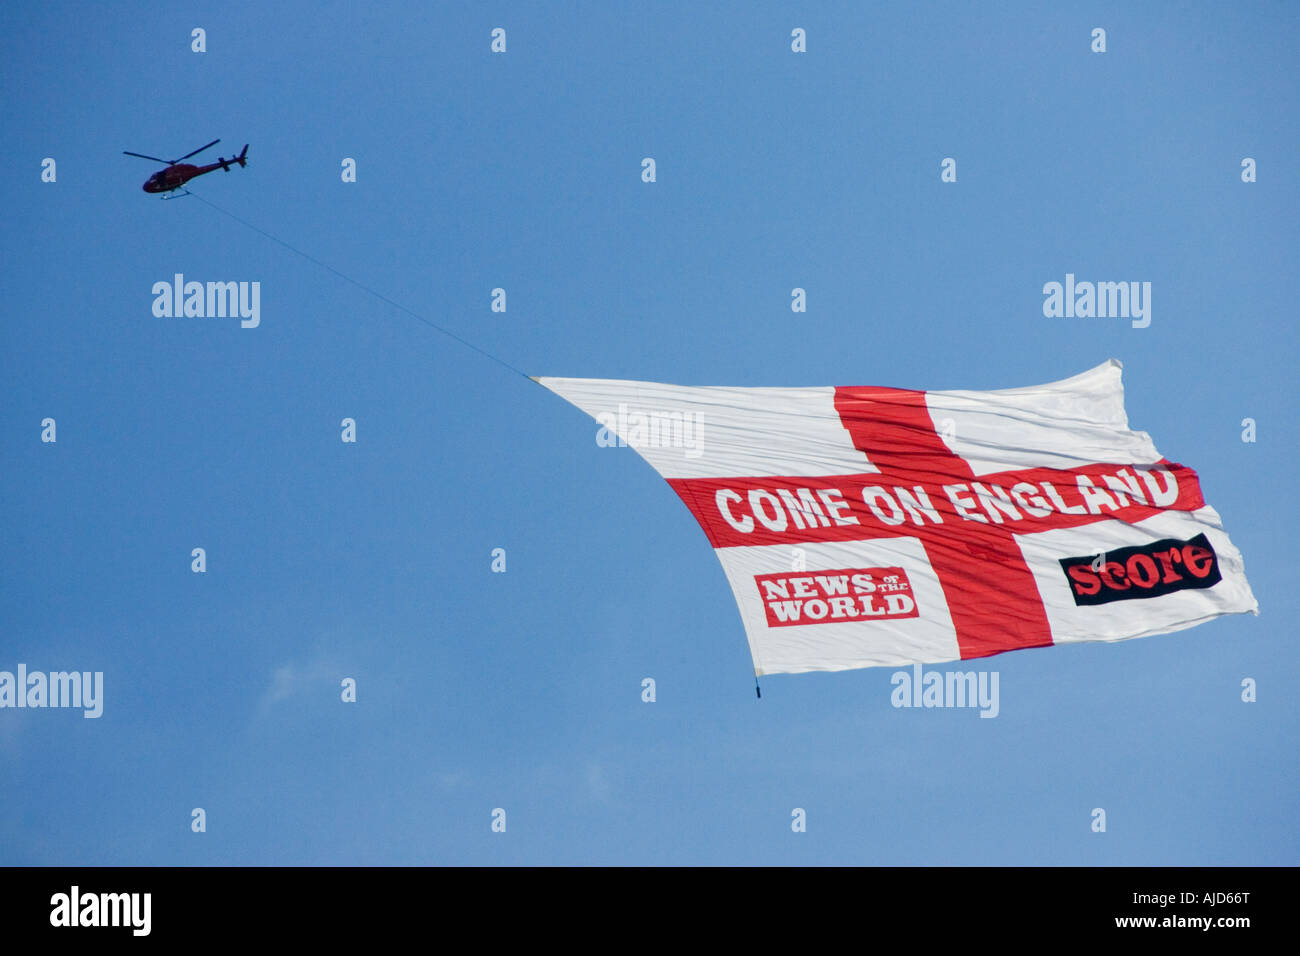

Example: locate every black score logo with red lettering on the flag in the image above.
[1060,535,1222,606]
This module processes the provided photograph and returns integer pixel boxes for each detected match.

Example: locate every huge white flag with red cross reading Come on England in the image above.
[537,359,1258,675]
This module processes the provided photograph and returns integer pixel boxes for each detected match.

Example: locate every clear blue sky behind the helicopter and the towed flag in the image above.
[0,3,1300,865]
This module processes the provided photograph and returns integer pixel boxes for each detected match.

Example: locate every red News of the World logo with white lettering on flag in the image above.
[754,567,918,627]
